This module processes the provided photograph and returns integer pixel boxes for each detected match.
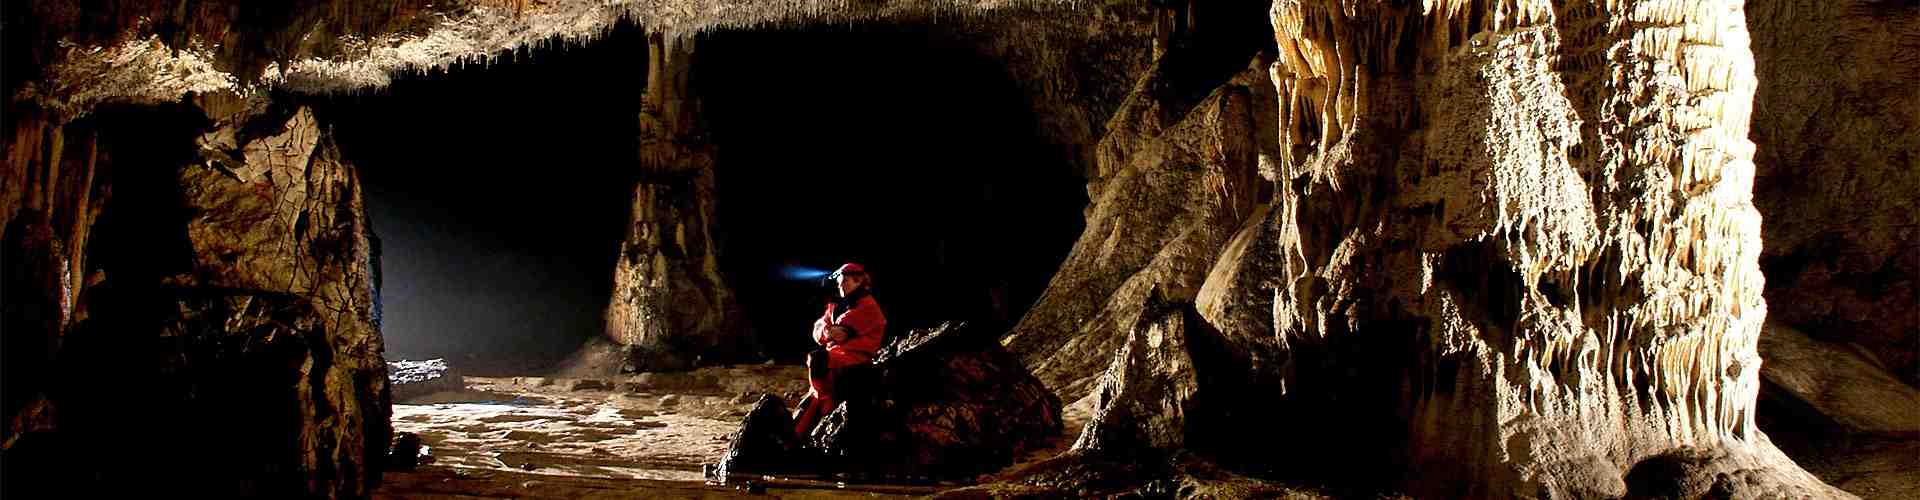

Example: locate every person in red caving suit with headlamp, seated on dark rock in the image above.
[793,263,887,438]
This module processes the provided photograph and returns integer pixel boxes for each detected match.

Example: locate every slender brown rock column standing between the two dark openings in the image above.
[595,33,741,373]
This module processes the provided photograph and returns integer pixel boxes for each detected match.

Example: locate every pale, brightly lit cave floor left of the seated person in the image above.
[374,365,975,498]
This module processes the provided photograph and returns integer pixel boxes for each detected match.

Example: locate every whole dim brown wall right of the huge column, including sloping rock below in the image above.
[1745,2,1920,498]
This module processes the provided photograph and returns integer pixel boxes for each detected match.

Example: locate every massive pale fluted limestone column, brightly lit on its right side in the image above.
[1273,0,1841,498]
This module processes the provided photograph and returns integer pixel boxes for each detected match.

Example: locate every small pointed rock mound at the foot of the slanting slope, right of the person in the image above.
[989,298,1305,498]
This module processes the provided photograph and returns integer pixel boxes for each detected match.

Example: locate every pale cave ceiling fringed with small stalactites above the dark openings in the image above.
[15,0,1152,106]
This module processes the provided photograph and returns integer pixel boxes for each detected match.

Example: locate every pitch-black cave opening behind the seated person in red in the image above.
[693,25,1087,358]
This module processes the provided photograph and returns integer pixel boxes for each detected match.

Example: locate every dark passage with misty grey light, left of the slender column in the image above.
[321,27,647,375]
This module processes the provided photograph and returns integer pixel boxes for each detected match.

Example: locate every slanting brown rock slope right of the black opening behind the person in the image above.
[1002,52,1265,398]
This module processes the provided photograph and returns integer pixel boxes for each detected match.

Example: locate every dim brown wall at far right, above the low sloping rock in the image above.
[1745,0,1920,385]
